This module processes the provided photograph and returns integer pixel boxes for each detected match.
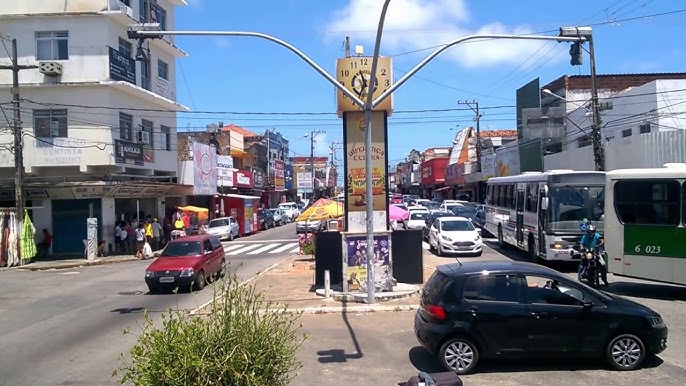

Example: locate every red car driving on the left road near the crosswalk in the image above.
[145,234,226,293]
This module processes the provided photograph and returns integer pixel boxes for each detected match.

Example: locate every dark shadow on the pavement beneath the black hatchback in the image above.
[408,346,664,374]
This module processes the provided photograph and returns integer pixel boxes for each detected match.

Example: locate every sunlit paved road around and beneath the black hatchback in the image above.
[293,238,686,386]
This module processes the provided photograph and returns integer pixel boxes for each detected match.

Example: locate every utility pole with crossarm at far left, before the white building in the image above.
[0,38,38,264]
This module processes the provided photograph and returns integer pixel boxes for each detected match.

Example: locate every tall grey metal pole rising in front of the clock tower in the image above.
[364,0,391,304]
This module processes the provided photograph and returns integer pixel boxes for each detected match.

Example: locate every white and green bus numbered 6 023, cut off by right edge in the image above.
[605,164,686,285]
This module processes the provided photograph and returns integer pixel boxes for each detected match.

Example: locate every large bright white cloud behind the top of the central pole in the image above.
[326,0,547,68]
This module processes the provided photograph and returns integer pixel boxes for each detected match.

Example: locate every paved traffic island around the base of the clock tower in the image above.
[253,255,420,314]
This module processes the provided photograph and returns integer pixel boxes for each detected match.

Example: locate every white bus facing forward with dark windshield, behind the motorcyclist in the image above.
[485,170,605,262]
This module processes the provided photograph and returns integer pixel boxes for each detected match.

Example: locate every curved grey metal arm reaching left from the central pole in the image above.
[134,29,370,108]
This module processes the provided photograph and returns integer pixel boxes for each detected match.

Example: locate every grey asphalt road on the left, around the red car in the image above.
[0,224,297,386]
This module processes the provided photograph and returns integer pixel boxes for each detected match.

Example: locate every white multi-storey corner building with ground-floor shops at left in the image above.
[0,0,187,255]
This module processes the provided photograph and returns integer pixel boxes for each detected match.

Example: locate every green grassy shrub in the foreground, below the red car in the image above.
[112,276,305,386]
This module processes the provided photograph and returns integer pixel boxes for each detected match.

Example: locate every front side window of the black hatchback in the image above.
[524,275,585,306]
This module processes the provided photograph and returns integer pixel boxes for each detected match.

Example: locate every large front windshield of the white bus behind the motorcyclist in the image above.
[548,186,605,232]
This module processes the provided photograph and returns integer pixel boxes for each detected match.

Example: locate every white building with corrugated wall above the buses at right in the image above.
[544,74,686,170]
